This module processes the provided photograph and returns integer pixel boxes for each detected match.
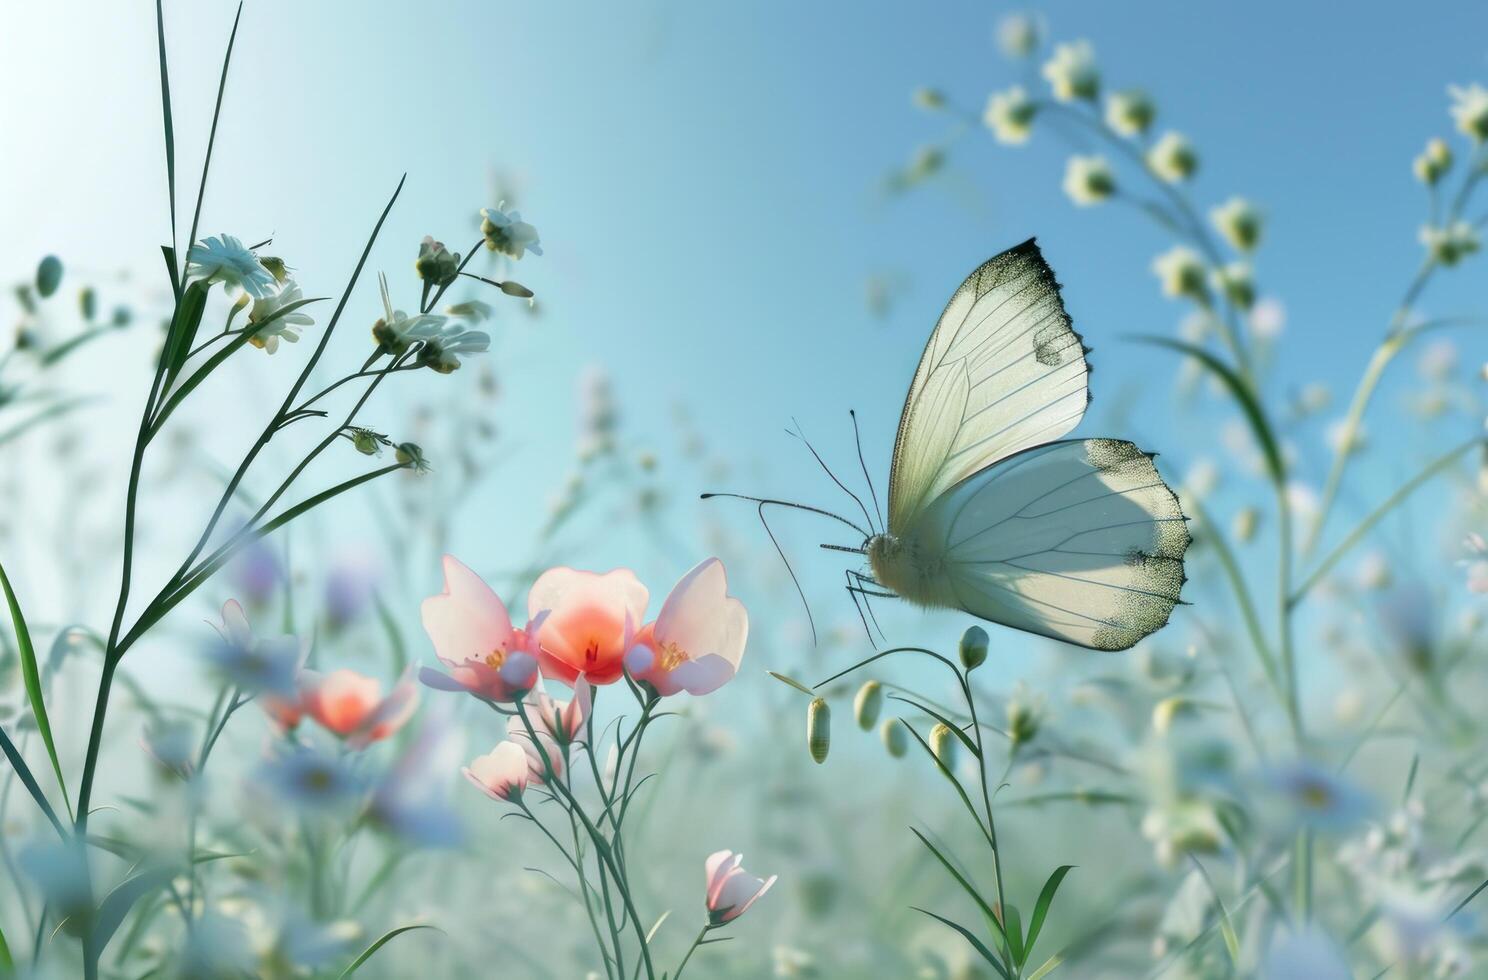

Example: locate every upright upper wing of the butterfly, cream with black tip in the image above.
[888,238,1089,534]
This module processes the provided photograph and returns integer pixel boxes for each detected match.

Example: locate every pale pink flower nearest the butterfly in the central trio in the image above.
[625,558,748,696]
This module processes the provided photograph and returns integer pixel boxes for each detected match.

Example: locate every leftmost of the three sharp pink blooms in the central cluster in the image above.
[418,555,540,702]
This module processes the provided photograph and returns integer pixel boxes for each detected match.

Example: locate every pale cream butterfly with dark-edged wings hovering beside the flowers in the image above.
[714,238,1190,650]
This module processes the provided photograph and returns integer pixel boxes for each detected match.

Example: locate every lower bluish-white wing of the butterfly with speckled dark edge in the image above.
[911,439,1190,650]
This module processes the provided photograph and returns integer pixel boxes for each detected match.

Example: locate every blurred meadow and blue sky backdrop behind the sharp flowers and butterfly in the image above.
[0,0,1488,980]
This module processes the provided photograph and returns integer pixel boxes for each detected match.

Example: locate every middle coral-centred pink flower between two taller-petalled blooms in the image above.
[527,567,650,686]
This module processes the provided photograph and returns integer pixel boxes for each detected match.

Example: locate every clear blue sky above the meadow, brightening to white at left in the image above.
[0,0,1488,681]
